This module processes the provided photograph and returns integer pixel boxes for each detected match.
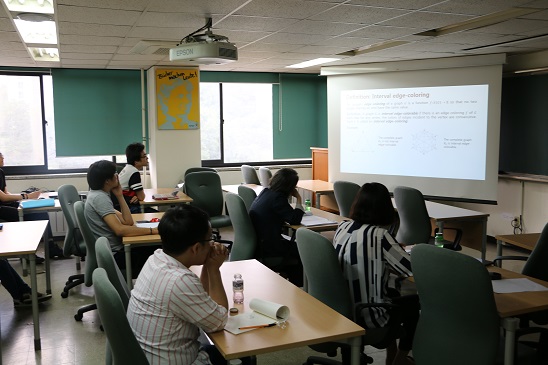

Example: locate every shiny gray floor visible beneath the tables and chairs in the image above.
[0,231,522,365]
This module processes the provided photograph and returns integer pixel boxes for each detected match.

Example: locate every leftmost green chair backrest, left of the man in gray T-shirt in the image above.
[57,184,86,257]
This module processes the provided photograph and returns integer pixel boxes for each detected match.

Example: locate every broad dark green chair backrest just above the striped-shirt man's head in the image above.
[185,171,223,217]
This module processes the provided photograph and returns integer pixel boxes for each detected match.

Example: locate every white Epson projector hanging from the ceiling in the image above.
[169,42,238,65]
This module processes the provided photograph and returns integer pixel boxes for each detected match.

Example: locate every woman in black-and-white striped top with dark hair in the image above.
[333,183,419,365]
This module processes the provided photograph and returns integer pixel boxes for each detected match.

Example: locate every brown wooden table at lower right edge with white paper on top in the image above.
[488,266,548,365]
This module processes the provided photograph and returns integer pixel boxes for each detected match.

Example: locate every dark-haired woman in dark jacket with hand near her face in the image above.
[249,168,304,286]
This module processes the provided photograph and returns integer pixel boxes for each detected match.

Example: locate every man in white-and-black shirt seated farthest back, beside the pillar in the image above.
[113,142,156,213]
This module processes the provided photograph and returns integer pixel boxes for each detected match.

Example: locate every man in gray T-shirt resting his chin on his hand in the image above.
[84,160,158,277]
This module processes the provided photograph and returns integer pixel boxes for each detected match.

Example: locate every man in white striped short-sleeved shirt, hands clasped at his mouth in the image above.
[127,205,232,364]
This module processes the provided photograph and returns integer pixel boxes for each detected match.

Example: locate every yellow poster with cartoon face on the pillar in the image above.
[156,69,200,129]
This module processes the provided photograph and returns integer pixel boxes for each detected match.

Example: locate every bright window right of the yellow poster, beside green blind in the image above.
[200,82,274,164]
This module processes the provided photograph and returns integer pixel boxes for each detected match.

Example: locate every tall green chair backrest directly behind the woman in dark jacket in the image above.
[225,189,257,261]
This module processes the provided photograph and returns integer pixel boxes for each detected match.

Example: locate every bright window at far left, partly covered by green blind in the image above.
[0,73,125,174]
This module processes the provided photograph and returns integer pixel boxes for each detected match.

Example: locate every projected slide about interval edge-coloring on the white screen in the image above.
[340,85,489,180]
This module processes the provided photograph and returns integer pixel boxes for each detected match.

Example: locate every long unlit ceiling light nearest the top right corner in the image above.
[415,8,544,37]
